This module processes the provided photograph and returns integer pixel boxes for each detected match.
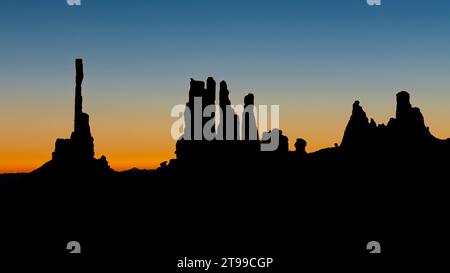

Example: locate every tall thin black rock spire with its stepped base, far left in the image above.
[33,59,112,175]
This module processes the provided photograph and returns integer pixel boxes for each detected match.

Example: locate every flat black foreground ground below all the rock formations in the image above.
[0,156,450,272]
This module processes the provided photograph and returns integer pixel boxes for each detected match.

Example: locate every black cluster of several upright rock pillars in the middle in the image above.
[174,77,276,172]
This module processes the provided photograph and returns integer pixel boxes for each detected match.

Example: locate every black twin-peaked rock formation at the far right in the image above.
[341,91,445,157]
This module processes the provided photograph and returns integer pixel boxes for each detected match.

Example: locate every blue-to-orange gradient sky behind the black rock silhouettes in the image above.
[0,0,450,173]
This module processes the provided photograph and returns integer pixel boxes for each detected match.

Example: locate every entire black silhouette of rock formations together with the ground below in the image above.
[2,59,450,264]
